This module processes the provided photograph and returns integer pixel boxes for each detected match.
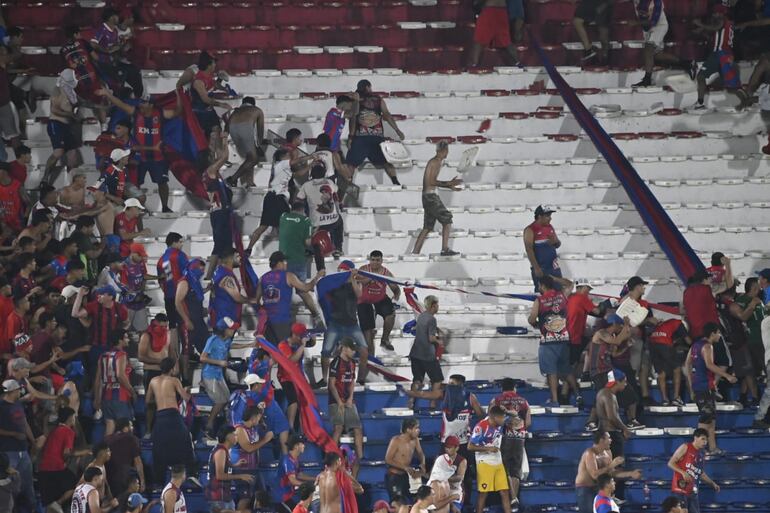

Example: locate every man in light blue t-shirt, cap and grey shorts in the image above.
[201,317,254,438]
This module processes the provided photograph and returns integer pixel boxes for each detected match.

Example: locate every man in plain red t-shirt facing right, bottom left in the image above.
[38,407,91,510]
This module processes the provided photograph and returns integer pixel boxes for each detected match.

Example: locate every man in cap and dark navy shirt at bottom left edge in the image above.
[0,379,37,513]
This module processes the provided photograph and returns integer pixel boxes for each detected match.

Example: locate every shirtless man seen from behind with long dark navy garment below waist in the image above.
[145,358,200,486]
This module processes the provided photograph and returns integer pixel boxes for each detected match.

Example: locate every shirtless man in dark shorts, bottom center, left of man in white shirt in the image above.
[385,417,425,501]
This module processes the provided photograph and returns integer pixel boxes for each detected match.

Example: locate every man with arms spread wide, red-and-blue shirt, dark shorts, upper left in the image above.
[96,89,182,212]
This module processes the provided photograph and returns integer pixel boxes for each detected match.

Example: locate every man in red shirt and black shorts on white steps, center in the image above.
[358,249,401,354]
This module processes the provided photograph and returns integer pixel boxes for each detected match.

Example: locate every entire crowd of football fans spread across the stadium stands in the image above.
[0,0,770,513]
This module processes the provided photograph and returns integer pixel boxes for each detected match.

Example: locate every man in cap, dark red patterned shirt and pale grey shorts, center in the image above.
[329,337,364,477]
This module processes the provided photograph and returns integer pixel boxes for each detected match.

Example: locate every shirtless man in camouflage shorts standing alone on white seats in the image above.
[412,141,463,256]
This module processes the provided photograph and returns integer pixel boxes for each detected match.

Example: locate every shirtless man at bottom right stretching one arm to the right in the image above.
[575,431,642,513]
